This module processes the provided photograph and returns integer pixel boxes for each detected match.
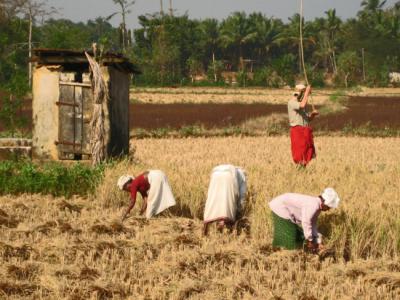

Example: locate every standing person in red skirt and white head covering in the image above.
[288,84,319,167]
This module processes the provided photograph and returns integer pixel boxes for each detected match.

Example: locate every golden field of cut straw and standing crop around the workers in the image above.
[0,137,400,299]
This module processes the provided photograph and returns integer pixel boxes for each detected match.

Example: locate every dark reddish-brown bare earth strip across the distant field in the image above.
[0,97,400,132]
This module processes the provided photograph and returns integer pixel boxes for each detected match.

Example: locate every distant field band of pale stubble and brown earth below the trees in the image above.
[0,88,400,137]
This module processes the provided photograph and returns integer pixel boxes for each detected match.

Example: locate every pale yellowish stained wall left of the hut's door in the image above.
[32,66,60,160]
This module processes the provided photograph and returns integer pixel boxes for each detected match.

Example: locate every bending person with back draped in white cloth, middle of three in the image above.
[203,165,247,235]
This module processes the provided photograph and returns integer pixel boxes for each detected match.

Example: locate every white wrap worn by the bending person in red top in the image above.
[146,170,176,219]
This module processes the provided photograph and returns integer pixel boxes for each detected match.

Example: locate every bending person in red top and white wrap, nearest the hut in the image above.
[117,170,176,221]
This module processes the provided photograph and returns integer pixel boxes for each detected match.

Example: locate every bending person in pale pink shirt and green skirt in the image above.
[269,188,340,253]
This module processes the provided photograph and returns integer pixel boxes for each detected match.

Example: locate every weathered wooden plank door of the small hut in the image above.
[56,82,93,160]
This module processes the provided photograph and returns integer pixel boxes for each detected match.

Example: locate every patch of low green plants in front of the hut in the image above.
[0,161,104,197]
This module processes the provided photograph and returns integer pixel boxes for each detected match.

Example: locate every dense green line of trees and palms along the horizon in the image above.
[0,0,400,92]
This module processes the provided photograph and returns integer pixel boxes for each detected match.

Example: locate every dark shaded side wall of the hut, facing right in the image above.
[108,67,130,156]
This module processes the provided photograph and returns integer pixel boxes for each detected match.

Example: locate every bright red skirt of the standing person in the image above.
[290,126,316,166]
